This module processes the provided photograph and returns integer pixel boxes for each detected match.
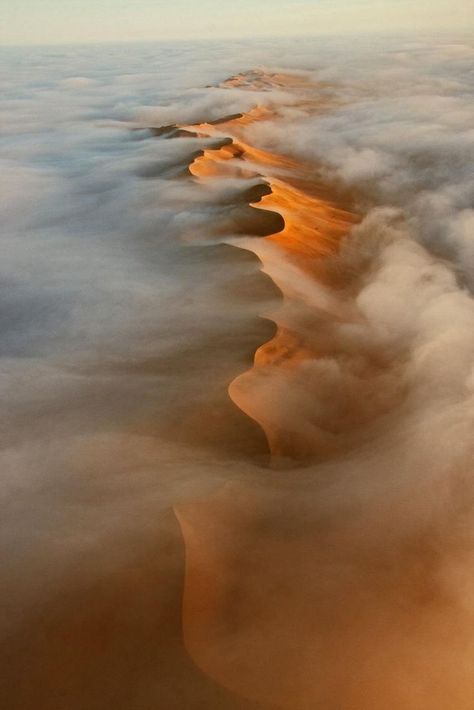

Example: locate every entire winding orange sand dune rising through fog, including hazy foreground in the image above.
[164,74,472,710]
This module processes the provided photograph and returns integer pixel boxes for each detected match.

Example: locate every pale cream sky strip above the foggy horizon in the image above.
[0,0,474,44]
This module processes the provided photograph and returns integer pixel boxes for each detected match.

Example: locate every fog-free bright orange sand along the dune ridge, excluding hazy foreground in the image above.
[179,72,359,465]
